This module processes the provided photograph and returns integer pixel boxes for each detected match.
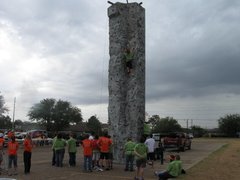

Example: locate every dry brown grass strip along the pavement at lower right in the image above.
[178,139,240,180]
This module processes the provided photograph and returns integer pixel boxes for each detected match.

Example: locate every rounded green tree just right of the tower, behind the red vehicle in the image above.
[153,117,182,133]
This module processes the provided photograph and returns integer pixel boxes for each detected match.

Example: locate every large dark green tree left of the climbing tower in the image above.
[28,98,82,131]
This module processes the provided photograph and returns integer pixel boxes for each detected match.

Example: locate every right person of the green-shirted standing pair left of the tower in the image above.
[67,133,77,167]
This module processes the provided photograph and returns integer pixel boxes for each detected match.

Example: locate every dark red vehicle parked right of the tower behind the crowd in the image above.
[163,132,192,151]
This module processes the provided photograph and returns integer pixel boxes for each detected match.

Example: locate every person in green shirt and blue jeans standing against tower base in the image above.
[124,138,136,171]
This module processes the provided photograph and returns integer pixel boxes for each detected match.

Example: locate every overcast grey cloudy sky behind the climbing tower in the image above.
[0,0,240,128]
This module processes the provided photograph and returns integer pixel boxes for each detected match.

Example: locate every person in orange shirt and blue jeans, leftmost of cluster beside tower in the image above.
[82,134,93,172]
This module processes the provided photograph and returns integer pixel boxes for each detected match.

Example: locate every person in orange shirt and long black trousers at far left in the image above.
[23,134,33,174]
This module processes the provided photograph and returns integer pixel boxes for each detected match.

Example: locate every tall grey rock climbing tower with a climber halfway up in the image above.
[108,2,145,162]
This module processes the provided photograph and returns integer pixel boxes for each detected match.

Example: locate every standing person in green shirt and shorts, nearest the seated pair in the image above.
[134,136,148,180]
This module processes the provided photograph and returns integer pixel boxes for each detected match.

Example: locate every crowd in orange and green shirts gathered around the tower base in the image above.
[0,133,185,180]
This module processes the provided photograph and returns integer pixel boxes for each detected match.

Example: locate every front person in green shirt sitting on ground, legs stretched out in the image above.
[155,155,179,180]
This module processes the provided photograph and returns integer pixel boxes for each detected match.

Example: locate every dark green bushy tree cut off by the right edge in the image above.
[218,114,240,137]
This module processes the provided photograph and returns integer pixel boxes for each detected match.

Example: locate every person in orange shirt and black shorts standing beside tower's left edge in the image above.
[98,132,112,171]
